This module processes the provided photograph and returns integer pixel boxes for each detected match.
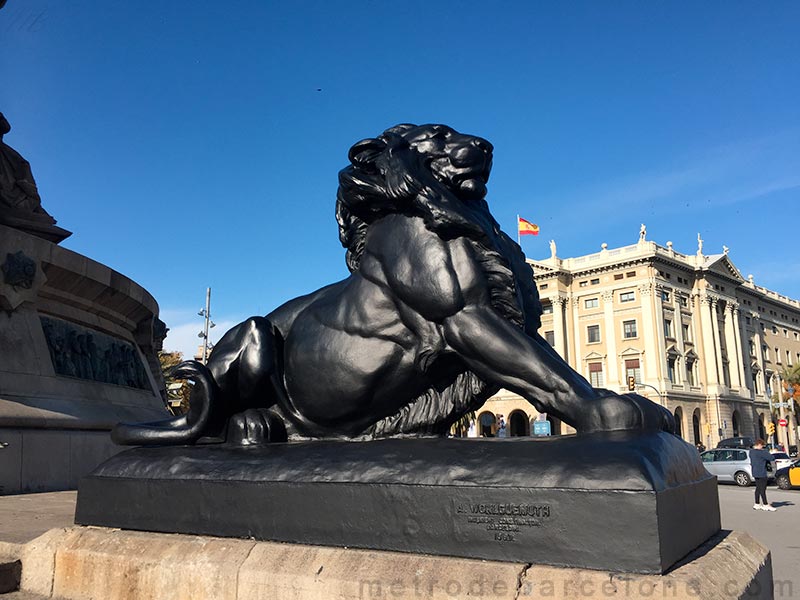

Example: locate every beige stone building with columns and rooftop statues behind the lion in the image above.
[475,234,800,447]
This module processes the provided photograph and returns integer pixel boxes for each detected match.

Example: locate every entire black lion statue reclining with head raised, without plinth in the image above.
[112,125,674,444]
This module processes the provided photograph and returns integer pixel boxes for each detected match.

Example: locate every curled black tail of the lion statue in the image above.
[111,360,219,446]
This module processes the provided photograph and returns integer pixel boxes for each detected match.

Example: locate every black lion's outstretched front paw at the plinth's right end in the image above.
[577,392,675,433]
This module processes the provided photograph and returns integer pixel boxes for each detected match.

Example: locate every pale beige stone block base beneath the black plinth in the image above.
[15,527,772,600]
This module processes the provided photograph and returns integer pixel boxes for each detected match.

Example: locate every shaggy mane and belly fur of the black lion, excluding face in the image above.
[336,124,541,436]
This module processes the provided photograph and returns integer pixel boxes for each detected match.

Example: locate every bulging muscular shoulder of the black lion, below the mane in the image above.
[359,215,488,321]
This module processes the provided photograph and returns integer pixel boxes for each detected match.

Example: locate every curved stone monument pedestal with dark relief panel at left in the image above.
[0,224,167,494]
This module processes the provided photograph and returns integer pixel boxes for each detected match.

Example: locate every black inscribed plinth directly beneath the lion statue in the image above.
[75,432,720,573]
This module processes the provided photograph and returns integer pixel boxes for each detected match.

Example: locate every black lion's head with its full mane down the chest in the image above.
[336,124,541,335]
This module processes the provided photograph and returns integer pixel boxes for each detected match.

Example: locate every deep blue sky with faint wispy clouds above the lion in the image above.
[0,0,800,354]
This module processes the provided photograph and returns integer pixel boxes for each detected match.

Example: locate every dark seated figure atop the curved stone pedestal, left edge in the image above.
[0,113,70,242]
